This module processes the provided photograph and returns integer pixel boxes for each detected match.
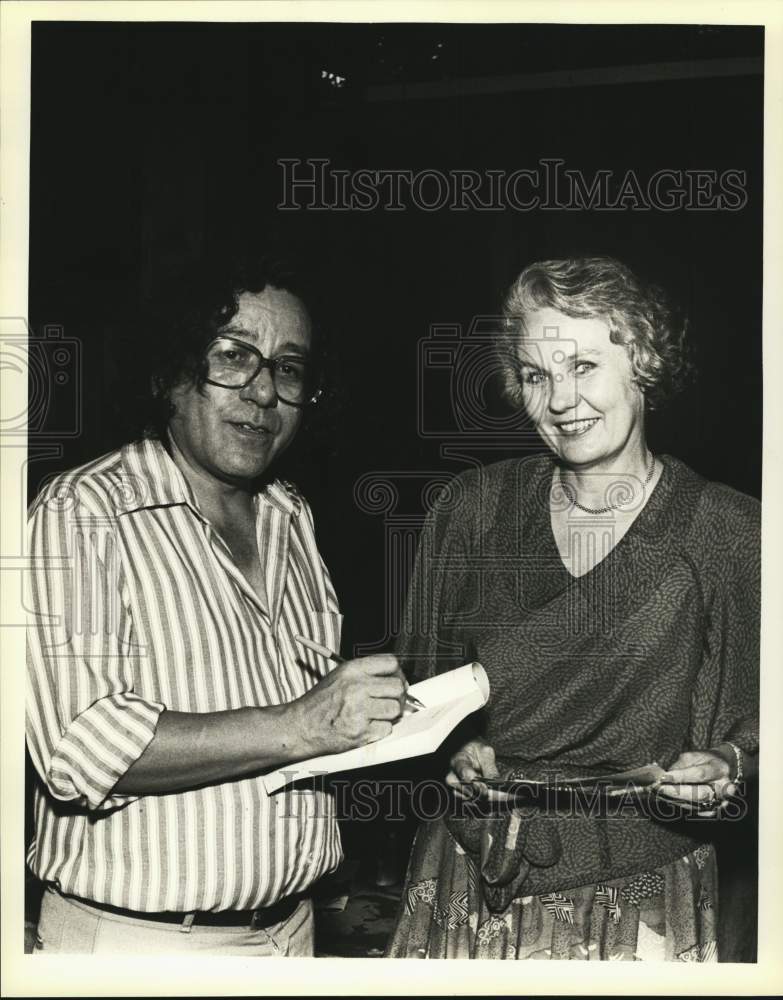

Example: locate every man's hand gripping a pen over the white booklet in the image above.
[293,655,407,754]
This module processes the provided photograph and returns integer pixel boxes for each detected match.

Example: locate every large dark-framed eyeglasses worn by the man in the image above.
[204,337,323,406]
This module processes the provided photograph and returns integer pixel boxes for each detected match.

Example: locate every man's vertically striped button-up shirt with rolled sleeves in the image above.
[26,440,342,912]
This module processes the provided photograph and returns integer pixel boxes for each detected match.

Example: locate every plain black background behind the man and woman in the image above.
[29,23,763,960]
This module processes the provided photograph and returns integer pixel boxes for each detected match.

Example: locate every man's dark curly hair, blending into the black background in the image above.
[107,244,344,489]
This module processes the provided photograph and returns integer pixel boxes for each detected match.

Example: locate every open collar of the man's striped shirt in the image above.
[116,438,302,521]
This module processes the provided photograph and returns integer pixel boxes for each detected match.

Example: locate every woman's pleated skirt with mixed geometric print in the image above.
[387,820,718,962]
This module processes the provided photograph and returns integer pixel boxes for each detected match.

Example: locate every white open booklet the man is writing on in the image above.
[263,663,489,794]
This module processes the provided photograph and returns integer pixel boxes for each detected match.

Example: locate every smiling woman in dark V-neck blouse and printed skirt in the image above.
[389,257,760,961]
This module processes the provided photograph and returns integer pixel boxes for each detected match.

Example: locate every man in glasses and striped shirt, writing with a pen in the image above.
[28,256,405,955]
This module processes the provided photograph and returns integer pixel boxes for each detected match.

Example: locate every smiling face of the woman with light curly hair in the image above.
[517,309,645,468]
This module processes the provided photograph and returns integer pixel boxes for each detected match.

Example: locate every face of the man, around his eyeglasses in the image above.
[169,287,311,485]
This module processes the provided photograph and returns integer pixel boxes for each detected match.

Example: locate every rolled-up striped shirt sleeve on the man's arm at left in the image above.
[26,485,165,810]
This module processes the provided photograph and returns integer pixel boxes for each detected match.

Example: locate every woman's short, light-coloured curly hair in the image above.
[498,257,693,410]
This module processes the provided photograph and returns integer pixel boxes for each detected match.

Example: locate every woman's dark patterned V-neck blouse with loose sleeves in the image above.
[399,456,761,894]
